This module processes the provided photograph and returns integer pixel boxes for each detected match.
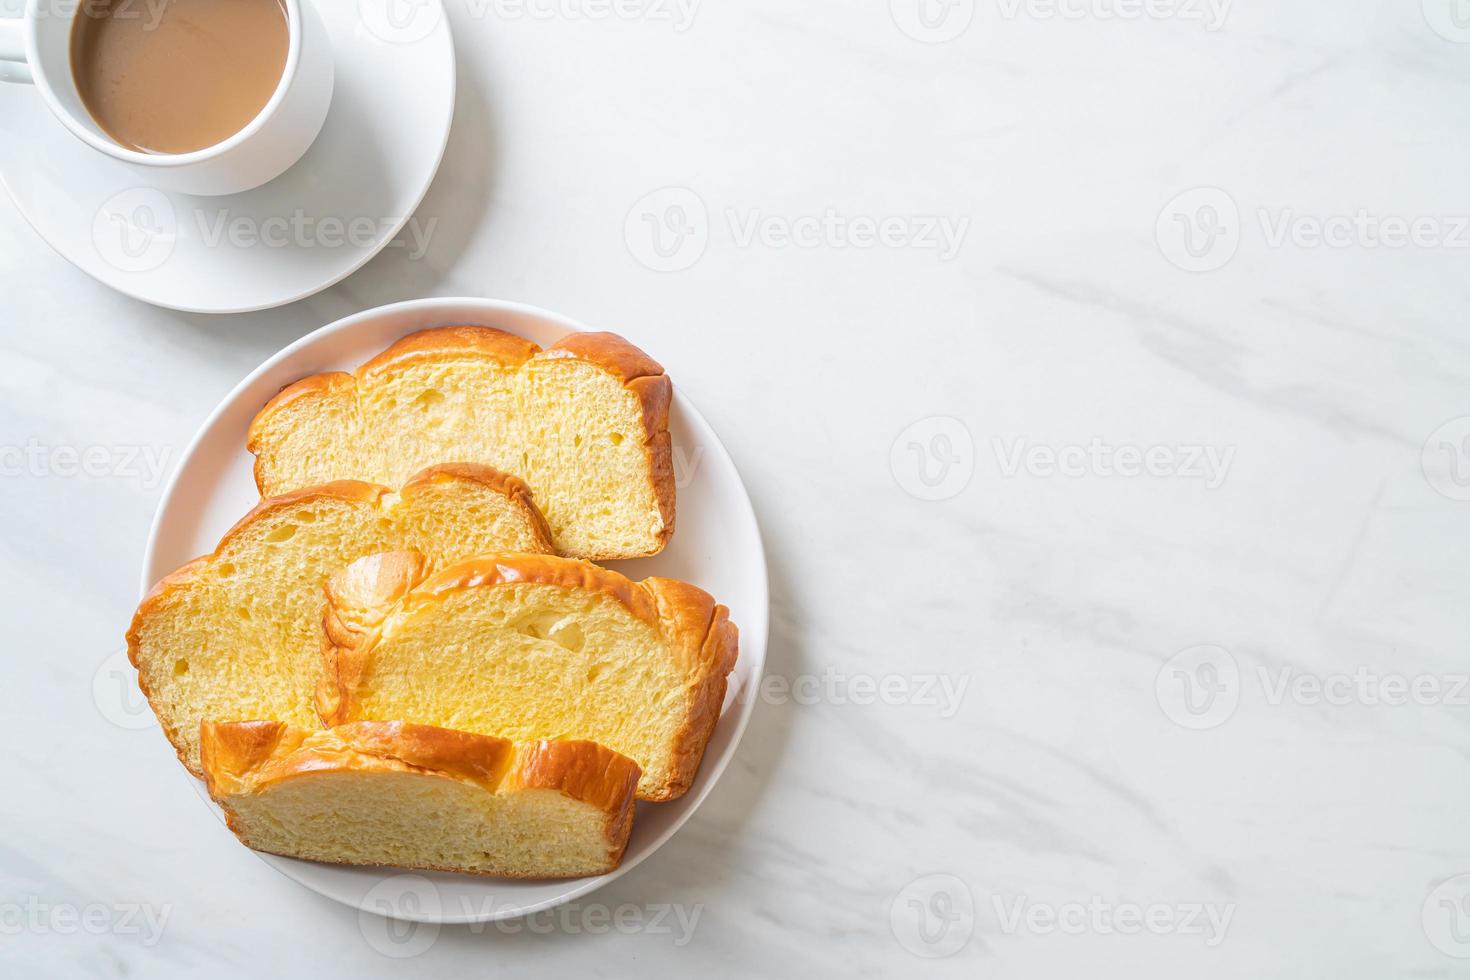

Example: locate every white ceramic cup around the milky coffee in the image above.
[0,0,343,195]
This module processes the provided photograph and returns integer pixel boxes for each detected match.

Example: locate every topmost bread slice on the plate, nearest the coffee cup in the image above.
[247,326,675,560]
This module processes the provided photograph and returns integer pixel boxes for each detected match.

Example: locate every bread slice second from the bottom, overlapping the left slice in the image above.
[318,552,738,799]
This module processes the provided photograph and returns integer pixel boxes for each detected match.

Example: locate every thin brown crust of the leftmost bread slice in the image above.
[126,463,553,777]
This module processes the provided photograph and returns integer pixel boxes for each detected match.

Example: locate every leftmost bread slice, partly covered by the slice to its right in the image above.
[128,466,551,776]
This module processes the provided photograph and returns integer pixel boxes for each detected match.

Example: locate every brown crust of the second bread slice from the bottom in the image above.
[318,551,739,801]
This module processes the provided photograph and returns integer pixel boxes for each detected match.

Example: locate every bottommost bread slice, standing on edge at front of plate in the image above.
[200,721,638,879]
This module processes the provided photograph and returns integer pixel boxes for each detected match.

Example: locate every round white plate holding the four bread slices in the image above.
[141,300,769,923]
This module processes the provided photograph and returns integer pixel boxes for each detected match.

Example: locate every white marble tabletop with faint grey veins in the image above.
[0,0,1470,979]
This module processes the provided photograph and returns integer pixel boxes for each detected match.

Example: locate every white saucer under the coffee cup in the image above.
[0,0,454,313]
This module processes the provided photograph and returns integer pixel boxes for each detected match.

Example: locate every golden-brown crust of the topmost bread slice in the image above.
[245,326,678,561]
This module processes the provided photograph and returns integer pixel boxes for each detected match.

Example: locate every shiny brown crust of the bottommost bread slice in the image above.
[200,721,639,879]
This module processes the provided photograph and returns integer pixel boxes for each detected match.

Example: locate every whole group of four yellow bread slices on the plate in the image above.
[128,326,736,879]
